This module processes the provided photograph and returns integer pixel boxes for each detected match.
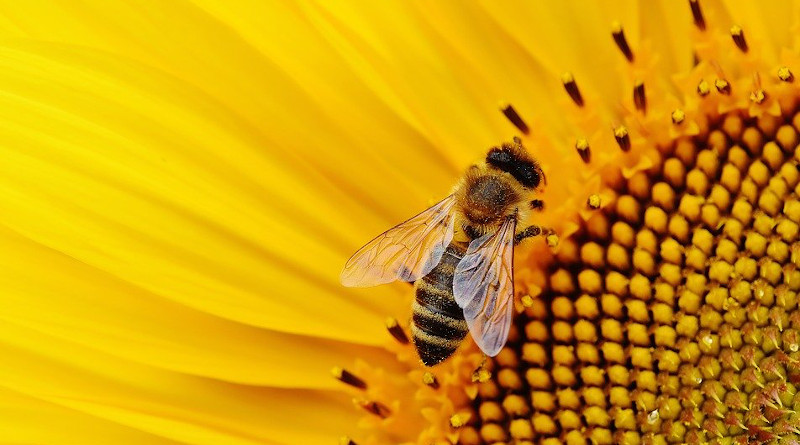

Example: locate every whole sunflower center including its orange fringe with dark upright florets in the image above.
[334,0,800,445]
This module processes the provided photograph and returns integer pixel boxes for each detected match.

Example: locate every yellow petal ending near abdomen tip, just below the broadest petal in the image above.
[0,224,400,388]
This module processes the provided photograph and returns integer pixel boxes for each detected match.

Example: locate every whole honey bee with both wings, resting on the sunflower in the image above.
[340,138,550,366]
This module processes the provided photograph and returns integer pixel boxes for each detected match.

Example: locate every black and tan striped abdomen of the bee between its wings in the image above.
[411,242,469,366]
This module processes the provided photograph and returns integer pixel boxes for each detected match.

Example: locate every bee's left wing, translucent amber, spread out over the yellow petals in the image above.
[339,195,456,287]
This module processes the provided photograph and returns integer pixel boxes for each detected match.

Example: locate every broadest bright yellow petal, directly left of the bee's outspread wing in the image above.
[0,42,412,344]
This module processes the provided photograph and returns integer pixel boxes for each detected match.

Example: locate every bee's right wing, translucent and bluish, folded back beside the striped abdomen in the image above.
[453,218,516,357]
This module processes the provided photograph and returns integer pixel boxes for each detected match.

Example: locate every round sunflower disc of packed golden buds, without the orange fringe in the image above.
[459,113,800,445]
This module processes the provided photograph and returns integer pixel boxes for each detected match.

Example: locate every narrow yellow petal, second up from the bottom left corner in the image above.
[0,322,355,444]
